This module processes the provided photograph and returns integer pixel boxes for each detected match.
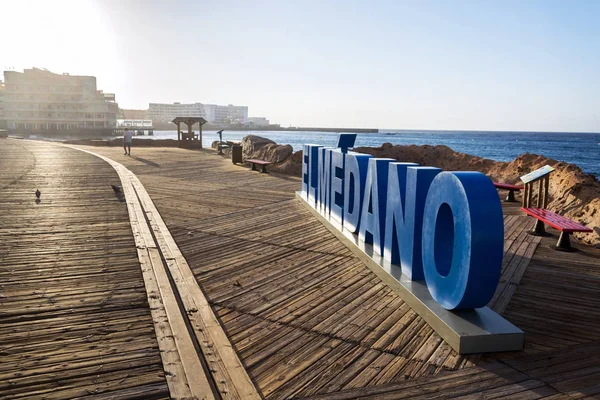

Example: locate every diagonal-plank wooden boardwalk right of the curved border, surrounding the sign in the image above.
[0,139,600,399]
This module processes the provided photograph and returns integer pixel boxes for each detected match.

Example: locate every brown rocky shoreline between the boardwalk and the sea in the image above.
[227,135,600,247]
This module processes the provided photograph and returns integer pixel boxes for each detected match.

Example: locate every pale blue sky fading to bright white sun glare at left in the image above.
[0,0,600,132]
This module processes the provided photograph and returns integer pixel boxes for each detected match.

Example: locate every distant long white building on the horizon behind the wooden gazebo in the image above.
[147,103,248,124]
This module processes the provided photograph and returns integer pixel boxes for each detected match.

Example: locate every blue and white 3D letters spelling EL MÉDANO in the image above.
[301,135,504,310]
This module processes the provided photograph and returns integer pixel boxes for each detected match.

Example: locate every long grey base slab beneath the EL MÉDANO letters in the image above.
[296,192,525,354]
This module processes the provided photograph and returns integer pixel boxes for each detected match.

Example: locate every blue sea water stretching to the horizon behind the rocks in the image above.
[146,130,600,177]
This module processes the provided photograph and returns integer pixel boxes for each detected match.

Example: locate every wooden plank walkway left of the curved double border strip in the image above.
[0,140,169,399]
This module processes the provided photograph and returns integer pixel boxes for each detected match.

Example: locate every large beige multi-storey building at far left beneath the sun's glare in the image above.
[4,68,118,135]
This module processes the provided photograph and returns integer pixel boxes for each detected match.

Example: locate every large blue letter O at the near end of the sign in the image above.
[422,172,504,310]
